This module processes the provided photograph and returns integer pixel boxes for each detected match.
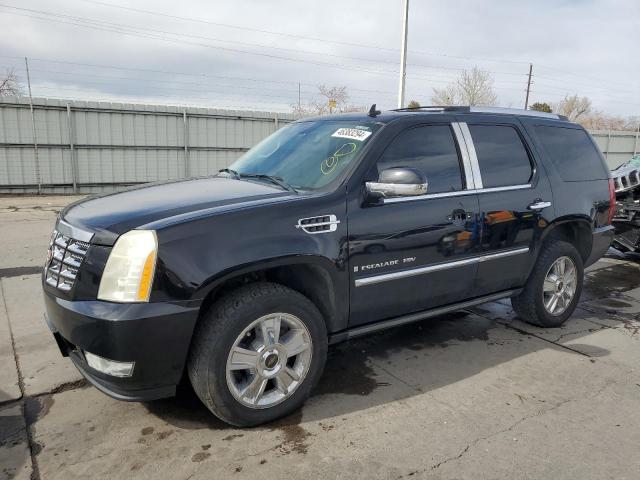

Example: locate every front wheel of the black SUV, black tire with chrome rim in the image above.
[187,282,328,427]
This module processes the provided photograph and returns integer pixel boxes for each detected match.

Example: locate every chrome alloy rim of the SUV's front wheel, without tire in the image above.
[226,313,313,408]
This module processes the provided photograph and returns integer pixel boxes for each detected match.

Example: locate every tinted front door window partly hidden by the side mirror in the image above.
[378,125,462,193]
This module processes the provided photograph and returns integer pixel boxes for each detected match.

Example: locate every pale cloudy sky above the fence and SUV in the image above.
[0,0,640,115]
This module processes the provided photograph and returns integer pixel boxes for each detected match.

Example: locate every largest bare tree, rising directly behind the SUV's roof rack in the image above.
[431,67,498,106]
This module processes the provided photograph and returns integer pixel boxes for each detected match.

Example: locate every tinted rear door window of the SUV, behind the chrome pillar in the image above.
[469,125,533,188]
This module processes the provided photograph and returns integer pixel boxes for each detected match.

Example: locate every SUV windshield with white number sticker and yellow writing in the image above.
[229,121,381,190]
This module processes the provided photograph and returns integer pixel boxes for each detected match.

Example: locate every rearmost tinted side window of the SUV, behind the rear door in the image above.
[536,126,608,182]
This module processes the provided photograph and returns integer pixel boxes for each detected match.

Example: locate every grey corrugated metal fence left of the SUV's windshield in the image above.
[0,97,294,193]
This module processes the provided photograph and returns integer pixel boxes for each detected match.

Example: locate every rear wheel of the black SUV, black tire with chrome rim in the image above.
[511,240,584,328]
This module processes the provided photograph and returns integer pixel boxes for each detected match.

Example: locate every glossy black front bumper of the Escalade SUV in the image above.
[44,292,199,401]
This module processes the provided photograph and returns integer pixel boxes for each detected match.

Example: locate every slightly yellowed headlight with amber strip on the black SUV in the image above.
[98,230,158,302]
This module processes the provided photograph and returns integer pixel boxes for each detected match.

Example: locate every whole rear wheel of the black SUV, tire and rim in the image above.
[511,240,584,327]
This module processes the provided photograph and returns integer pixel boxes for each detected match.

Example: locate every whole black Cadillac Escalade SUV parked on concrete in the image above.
[43,107,614,426]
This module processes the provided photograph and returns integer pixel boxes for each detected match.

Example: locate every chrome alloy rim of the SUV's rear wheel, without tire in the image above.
[542,257,578,315]
